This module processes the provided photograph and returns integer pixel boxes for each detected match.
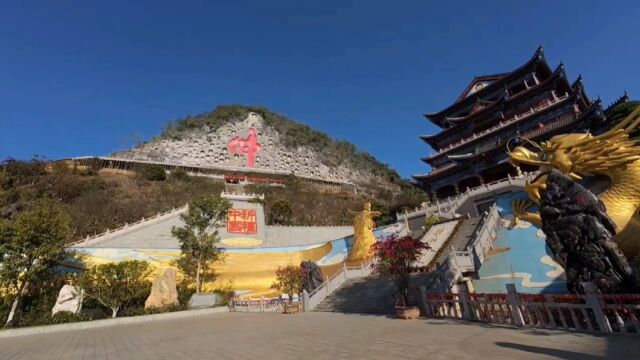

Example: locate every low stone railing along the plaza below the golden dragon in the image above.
[419,283,640,335]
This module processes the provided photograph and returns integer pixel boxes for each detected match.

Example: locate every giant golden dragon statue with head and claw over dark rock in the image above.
[509,102,640,259]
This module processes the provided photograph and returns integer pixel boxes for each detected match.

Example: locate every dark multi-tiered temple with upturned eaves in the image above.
[413,47,605,199]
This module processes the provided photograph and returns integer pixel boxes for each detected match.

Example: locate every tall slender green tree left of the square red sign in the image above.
[171,195,231,293]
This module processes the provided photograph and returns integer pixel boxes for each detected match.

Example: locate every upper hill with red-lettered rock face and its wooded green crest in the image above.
[113,105,402,193]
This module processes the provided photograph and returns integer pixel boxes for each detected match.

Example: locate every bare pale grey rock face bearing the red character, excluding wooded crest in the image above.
[113,112,377,184]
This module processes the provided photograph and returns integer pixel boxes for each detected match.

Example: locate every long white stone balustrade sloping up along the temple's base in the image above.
[396,171,538,219]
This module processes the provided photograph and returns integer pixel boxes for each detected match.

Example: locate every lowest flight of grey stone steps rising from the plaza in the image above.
[312,277,397,315]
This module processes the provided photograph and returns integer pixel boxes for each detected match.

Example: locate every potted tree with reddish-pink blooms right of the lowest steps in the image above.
[372,236,429,319]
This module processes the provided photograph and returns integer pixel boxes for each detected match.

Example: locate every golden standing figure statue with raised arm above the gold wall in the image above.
[347,202,381,263]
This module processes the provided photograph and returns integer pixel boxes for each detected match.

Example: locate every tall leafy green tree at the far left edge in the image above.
[0,202,70,327]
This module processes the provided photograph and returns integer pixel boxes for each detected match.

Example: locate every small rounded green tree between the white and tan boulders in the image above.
[78,260,151,317]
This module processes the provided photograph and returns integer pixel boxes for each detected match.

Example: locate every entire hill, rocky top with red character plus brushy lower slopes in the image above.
[0,105,425,240]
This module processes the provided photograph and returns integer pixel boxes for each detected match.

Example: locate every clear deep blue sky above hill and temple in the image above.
[0,0,640,177]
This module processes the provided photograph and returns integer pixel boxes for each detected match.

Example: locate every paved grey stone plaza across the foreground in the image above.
[0,313,640,360]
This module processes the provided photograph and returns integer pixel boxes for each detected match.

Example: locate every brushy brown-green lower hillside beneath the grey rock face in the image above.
[0,159,424,241]
